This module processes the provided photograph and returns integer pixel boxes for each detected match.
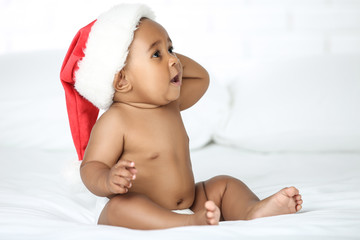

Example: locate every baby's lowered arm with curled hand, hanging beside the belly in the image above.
[80,111,136,197]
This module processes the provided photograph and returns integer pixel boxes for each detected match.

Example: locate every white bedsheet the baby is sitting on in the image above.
[0,145,360,240]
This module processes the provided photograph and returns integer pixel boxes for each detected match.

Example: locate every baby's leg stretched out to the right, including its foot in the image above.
[192,176,302,220]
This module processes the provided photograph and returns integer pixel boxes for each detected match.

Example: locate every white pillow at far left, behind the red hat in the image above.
[0,51,74,150]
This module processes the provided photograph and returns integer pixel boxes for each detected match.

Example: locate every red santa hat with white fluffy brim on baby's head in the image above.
[60,4,155,160]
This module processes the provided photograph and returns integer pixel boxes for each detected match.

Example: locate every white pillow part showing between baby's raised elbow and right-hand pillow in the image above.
[181,78,230,150]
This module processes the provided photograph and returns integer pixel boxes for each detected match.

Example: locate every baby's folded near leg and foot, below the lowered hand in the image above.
[98,193,220,229]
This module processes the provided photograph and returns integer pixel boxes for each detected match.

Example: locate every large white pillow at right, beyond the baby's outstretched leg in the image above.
[215,56,360,152]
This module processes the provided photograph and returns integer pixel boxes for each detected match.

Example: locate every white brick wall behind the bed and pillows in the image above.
[0,0,360,75]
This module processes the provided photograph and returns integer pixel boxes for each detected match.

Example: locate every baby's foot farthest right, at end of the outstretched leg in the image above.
[248,187,303,219]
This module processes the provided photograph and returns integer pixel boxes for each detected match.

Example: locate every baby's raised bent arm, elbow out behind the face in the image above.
[176,53,209,110]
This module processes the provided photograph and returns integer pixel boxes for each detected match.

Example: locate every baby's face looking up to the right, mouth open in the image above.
[124,19,182,106]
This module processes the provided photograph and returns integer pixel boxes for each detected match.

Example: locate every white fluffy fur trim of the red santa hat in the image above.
[75,4,155,109]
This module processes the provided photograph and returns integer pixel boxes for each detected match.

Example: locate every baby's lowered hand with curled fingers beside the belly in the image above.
[107,159,137,194]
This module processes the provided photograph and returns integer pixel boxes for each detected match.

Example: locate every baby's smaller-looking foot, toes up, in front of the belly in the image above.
[191,201,220,225]
